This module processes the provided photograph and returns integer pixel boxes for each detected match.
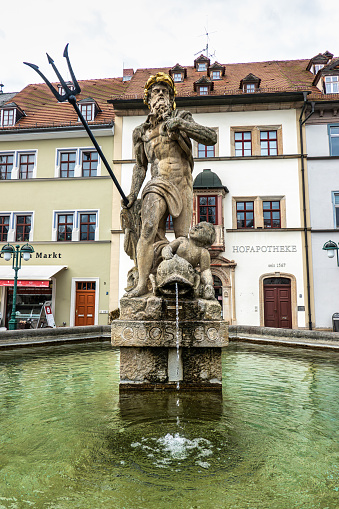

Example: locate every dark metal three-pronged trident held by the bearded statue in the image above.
[24,44,128,207]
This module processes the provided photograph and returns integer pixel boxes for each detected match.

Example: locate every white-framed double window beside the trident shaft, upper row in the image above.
[55,148,101,178]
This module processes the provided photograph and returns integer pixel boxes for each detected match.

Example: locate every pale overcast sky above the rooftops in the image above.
[0,0,339,92]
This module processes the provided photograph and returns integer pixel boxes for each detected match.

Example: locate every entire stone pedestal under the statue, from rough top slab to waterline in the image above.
[112,296,228,391]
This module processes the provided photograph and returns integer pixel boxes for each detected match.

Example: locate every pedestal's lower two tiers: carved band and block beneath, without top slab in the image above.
[112,320,228,391]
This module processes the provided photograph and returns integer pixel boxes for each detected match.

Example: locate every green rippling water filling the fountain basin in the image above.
[0,343,339,509]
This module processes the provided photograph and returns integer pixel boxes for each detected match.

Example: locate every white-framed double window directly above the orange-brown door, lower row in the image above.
[52,210,99,242]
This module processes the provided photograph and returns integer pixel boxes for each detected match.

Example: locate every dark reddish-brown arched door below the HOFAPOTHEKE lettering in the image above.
[263,277,292,329]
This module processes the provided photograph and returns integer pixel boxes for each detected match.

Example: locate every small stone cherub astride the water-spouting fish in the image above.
[162,221,215,300]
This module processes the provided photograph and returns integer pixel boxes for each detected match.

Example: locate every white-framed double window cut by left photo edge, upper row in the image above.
[0,150,37,180]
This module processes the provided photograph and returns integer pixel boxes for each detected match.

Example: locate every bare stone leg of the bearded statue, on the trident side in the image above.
[128,193,167,297]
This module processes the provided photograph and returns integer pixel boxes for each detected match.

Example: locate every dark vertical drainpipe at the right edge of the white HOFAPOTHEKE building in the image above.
[299,92,315,330]
